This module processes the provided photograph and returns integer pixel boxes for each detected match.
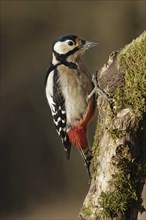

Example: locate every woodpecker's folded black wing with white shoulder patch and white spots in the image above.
[46,66,71,159]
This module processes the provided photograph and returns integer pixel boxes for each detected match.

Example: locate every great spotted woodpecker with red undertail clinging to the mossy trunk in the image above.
[45,35,97,175]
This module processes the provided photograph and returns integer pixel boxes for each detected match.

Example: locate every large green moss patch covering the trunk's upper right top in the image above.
[113,32,146,113]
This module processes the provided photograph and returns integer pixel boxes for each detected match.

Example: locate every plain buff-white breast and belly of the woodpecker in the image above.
[59,66,88,125]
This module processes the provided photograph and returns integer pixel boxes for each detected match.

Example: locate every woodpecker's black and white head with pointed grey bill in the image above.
[52,35,98,64]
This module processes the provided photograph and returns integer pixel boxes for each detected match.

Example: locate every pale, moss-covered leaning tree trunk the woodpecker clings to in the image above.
[78,32,146,220]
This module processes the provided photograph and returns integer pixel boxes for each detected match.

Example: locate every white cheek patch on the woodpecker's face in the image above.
[54,41,74,54]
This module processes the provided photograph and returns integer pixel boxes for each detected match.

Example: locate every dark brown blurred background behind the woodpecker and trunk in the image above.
[0,0,145,220]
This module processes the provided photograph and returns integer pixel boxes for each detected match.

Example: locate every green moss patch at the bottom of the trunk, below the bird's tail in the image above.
[99,156,138,219]
